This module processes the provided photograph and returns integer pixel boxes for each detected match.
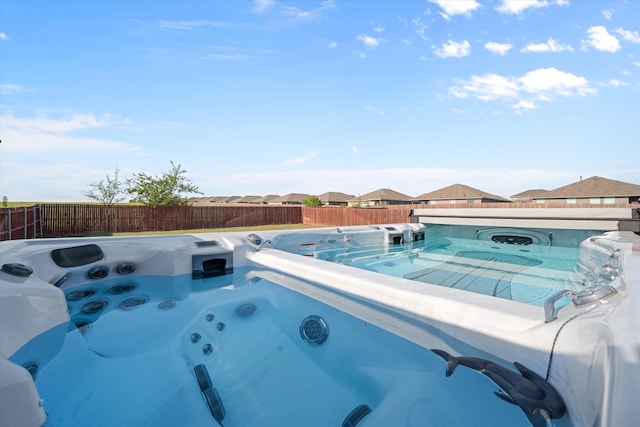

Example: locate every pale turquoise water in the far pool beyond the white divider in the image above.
[314,227,585,306]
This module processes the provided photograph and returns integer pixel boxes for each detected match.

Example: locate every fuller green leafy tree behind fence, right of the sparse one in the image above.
[127,162,202,207]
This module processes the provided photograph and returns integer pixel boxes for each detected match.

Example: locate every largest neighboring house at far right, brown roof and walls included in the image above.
[533,176,640,205]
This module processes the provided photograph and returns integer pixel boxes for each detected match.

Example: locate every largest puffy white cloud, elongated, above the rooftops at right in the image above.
[449,68,596,112]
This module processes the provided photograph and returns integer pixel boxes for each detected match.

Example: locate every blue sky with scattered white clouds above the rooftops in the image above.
[0,0,640,201]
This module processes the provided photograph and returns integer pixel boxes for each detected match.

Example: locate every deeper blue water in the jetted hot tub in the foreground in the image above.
[36,270,570,427]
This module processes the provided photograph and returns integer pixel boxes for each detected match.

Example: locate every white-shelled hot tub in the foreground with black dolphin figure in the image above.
[0,224,640,427]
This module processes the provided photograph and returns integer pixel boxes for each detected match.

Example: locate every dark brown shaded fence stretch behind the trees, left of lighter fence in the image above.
[42,203,302,237]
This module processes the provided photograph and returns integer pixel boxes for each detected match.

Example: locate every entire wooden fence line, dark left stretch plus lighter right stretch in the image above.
[7,203,630,240]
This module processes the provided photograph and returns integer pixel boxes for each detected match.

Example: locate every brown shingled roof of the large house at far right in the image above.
[538,176,640,199]
